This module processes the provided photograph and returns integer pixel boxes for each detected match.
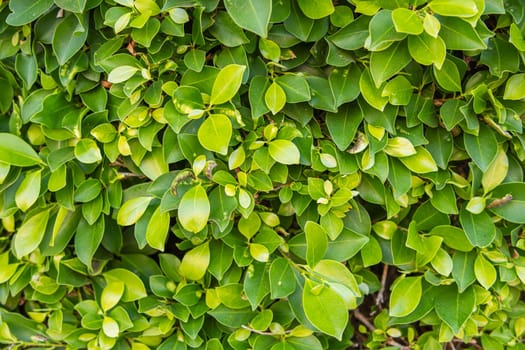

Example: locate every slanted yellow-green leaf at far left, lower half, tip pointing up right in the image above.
[13,209,50,259]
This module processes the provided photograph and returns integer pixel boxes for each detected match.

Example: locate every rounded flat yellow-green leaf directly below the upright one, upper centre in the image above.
[197,114,232,155]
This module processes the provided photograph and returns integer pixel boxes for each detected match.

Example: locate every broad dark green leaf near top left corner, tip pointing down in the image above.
[53,15,89,65]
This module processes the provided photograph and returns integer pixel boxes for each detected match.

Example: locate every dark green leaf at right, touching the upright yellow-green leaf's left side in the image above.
[463,125,498,172]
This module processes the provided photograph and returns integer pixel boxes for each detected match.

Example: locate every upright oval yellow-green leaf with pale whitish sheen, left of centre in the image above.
[177,185,210,233]
